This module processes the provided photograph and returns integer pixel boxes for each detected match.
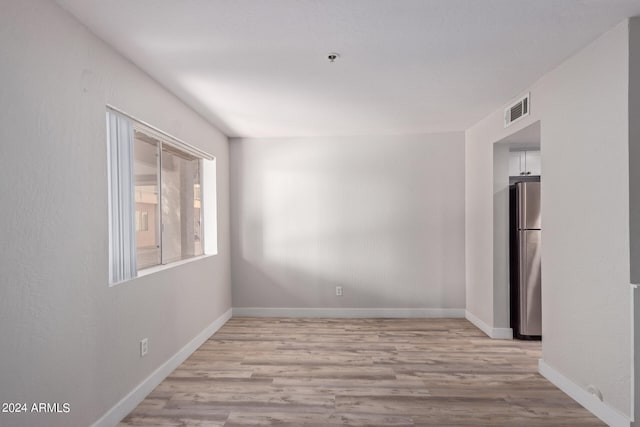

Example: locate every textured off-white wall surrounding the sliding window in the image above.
[0,0,231,426]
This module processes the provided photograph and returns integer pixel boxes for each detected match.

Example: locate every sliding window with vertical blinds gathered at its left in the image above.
[107,109,215,284]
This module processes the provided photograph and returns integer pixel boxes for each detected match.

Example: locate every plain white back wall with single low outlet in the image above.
[231,133,464,315]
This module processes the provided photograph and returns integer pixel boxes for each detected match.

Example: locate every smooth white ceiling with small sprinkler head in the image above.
[58,0,640,137]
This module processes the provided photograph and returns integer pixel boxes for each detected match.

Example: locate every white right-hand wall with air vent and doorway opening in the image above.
[465,22,631,422]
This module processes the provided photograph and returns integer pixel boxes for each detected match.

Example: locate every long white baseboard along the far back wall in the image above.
[233,307,464,318]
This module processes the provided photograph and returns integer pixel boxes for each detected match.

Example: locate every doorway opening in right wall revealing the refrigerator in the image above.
[493,121,542,339]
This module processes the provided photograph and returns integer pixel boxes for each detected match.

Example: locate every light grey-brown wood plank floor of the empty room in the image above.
[121,318,604,427]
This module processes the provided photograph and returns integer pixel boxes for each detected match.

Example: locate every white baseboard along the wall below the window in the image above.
[92,309,232,427]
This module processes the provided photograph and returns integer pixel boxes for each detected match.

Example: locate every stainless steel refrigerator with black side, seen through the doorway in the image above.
[509,182,542,339]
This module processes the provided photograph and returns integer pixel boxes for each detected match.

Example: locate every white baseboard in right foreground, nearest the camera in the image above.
[538,359,631,427]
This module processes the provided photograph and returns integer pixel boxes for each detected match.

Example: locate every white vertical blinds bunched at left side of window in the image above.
[107,110,137,284]
